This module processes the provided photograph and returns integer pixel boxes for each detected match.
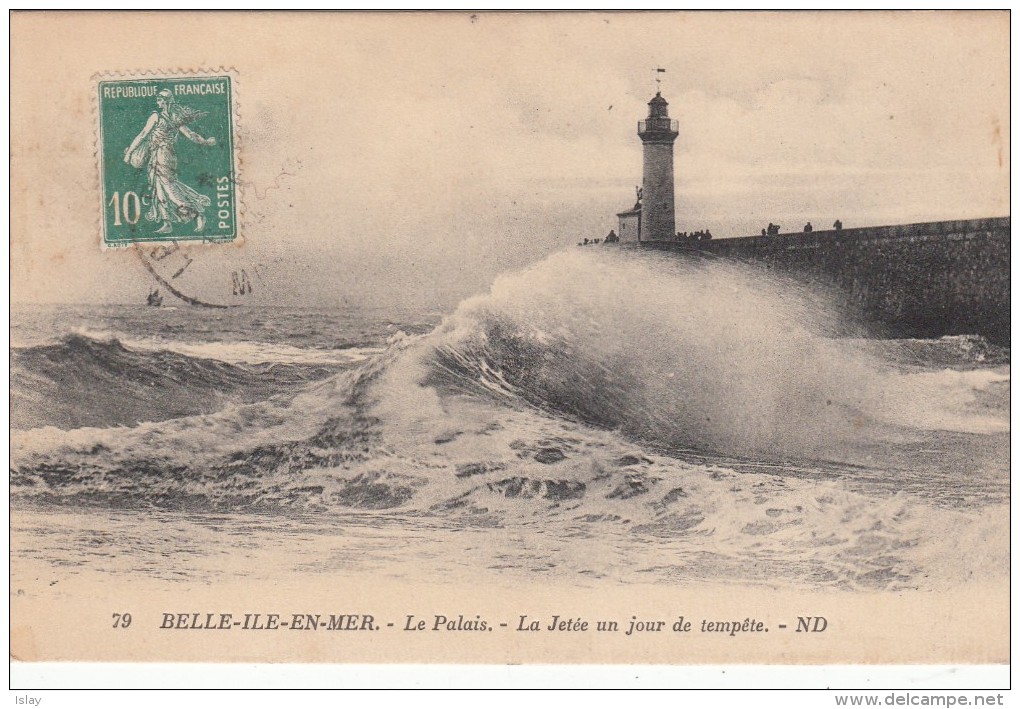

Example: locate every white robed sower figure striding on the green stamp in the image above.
[124,89,216,234]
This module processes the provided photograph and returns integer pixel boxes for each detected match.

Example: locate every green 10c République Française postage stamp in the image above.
[96,71,240,247]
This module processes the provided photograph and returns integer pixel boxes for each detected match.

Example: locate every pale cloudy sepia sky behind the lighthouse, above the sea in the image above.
[11,12,1010,308]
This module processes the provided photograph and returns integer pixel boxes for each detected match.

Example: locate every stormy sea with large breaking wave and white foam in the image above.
[10,250,1010,591]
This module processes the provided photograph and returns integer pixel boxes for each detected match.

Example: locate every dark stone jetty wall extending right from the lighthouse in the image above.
[635,217,1010,345]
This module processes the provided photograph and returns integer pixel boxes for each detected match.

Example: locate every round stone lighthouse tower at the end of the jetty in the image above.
[638,93,679,241]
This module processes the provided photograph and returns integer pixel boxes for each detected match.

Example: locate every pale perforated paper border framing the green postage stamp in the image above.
[89,66,245,251]
